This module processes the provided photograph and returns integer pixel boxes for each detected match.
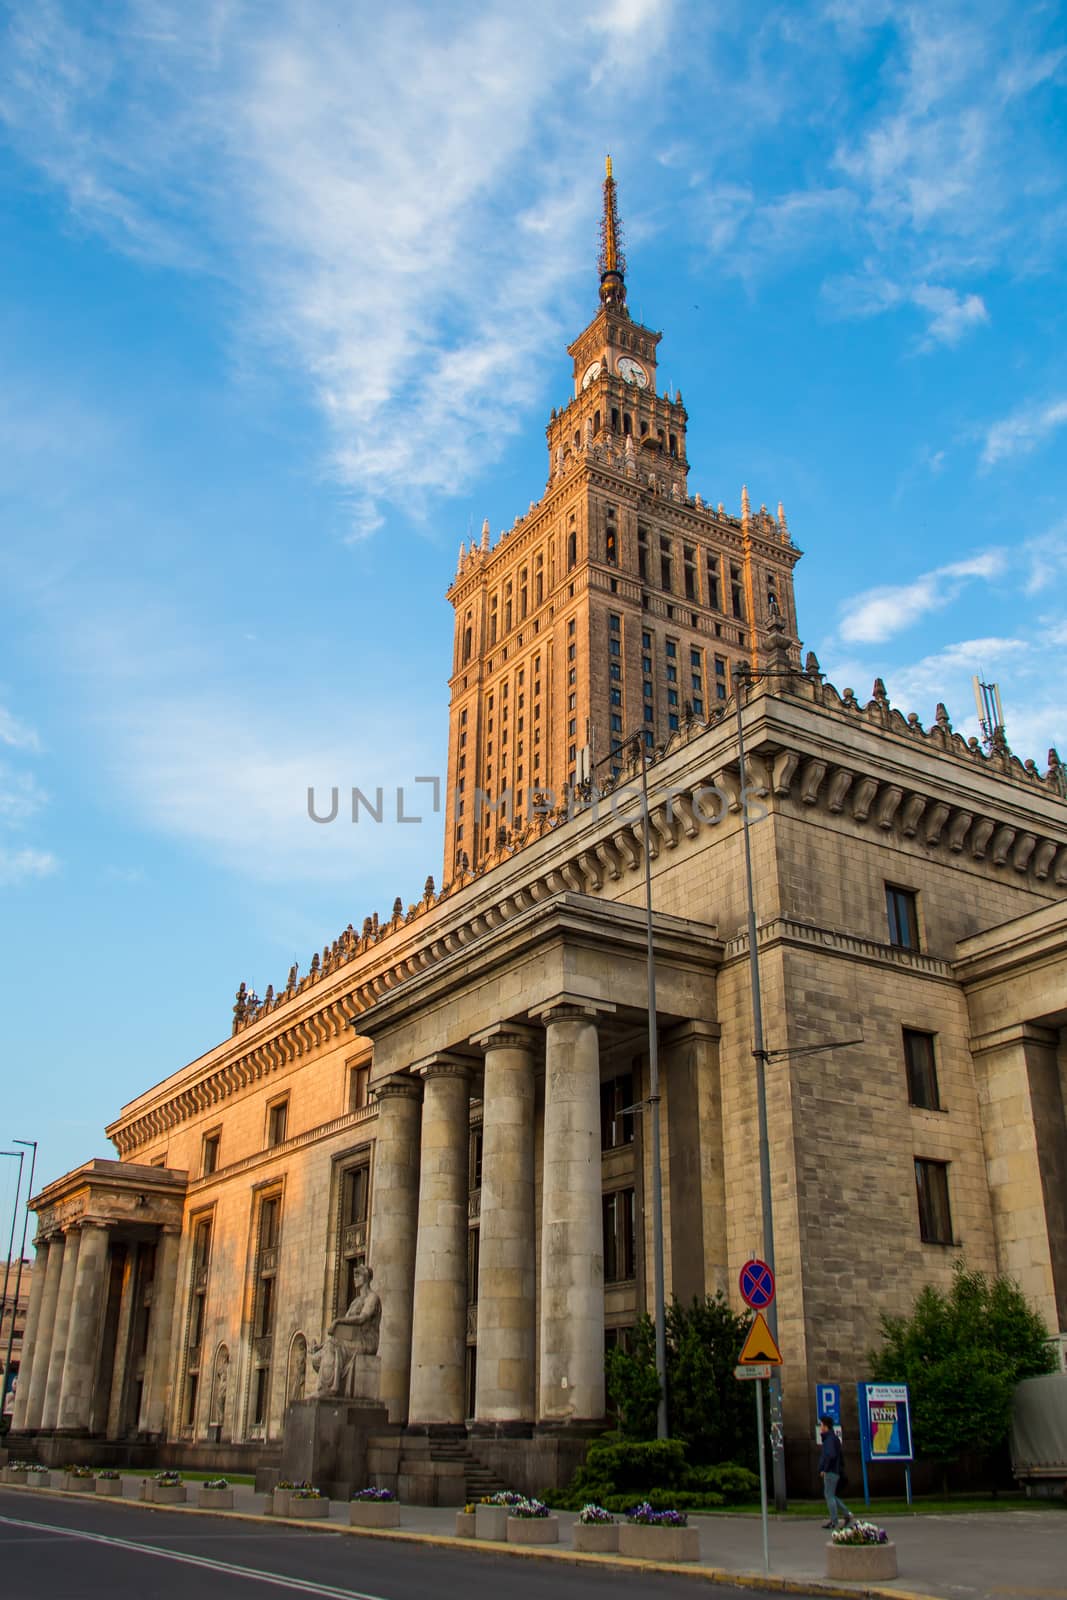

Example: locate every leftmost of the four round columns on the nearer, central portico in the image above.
[370,1074,422,1422]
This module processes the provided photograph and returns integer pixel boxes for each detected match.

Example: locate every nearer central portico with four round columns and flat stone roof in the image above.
[354,894,721,1437]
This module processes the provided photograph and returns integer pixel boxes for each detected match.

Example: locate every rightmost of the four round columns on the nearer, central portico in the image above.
[537,997,613,1424]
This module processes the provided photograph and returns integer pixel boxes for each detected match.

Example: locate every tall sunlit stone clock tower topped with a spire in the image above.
[445,158,800,880]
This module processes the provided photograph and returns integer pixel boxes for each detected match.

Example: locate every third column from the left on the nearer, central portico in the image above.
[472,1022,536,1424]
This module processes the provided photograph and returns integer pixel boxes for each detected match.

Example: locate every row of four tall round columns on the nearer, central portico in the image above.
[371,998,614,1429]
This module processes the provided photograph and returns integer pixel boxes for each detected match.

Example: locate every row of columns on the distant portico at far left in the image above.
[11,1216,181,1434]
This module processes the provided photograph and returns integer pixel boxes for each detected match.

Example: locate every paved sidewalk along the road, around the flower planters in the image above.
[5,1474,1067,1600]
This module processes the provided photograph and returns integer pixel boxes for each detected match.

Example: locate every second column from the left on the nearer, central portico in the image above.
[408,1054,470,1422]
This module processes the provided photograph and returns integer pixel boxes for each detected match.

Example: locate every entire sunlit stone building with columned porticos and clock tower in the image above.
[14,172,1067,1499]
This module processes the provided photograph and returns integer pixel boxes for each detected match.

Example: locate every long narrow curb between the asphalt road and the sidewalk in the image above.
[0,1483,944,1600]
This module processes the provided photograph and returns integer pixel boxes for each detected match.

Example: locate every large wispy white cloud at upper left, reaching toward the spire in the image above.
[0,0,672,536]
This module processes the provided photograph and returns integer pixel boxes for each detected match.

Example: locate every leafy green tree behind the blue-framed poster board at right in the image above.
[870,1261,1056,1466]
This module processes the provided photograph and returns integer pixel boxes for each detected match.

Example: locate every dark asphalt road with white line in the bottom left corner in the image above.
[0,1490,781,1600]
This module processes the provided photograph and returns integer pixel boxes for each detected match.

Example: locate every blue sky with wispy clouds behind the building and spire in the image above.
[0,0,1067,1181]
